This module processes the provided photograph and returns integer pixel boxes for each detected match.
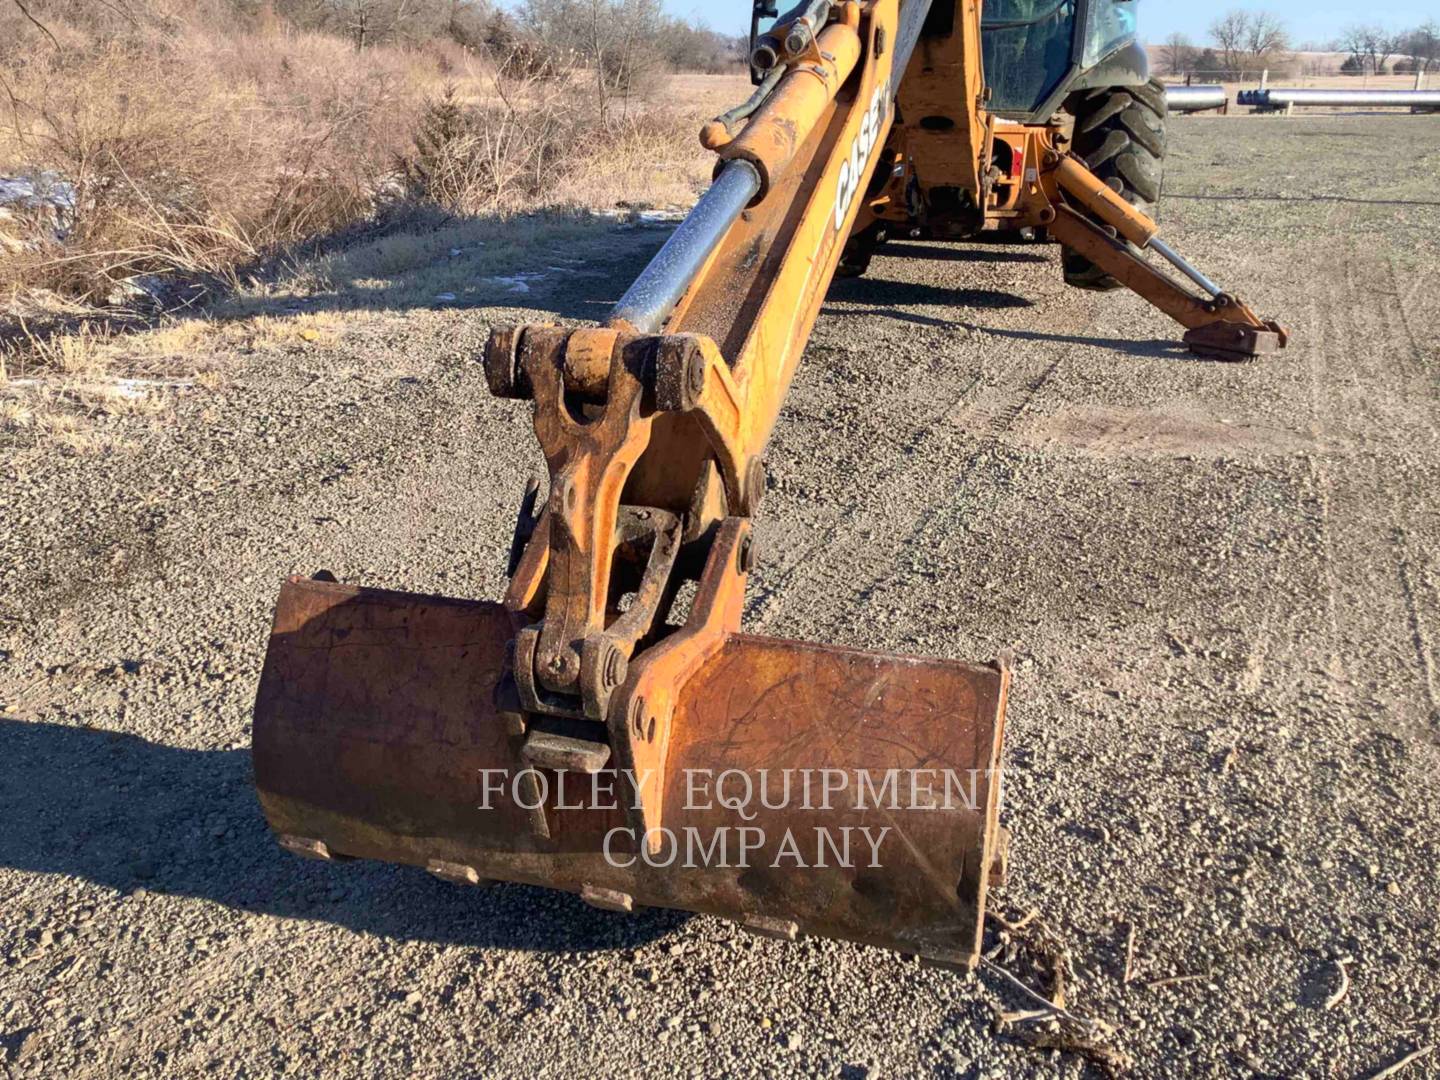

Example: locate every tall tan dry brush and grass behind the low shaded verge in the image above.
[0,6,731,310]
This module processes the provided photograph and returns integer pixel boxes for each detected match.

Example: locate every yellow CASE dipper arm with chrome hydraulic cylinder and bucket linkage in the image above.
[485,0,929,834]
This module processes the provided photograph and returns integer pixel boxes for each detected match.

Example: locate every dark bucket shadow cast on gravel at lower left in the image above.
[0,720,691,952]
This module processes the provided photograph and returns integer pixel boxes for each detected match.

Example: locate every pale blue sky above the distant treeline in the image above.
[665,0,1440,45]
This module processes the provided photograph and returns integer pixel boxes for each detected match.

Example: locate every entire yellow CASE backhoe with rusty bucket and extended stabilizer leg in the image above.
[253,0,1286,968]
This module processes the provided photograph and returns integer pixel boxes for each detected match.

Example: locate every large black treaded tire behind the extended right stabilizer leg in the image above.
[1063,79,1166,292]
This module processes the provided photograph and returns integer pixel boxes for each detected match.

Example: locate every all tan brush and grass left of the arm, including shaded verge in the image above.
[0,0,749,452]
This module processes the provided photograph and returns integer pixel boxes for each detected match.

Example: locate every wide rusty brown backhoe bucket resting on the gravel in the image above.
[253,579,1008,966]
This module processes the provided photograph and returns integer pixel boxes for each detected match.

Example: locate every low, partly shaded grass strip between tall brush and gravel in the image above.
[0,213,630,454]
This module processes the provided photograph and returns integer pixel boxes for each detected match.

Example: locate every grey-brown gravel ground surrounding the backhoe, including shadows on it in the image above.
[0,117,1440,1077]
